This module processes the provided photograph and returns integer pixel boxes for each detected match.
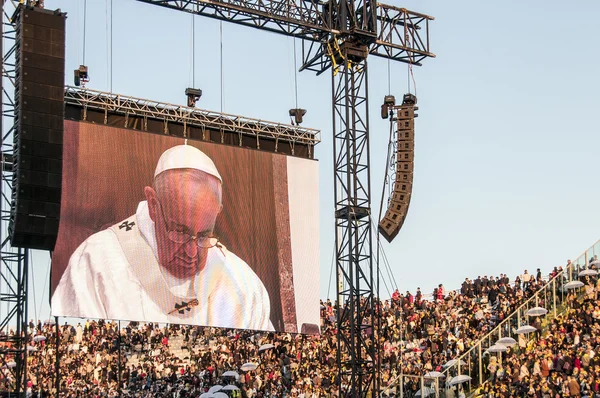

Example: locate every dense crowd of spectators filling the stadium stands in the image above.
[1,260,600,398]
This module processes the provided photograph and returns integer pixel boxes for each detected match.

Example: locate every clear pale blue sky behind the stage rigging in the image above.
[18,0,600,318]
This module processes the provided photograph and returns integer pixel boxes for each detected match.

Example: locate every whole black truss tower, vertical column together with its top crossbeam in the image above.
[138,0,434,397]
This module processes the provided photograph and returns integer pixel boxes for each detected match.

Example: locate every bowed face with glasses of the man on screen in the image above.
[145,172,221,279]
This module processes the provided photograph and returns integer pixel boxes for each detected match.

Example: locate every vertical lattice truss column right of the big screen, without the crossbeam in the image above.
[332,54,379,397]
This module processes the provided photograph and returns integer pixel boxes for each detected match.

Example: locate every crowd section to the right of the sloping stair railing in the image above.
[479,264,600,398]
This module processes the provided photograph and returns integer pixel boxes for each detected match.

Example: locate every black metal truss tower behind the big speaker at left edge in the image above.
[0,0,29,396]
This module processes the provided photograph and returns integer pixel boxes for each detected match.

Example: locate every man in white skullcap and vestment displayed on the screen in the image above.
[52,145,273,330]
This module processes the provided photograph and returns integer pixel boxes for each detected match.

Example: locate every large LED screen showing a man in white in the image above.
[51,121,319,333]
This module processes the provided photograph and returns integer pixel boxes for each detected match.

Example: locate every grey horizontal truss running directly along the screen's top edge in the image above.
[65,87,321,153]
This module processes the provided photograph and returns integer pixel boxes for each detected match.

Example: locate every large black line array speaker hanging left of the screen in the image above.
[9,5,66,250]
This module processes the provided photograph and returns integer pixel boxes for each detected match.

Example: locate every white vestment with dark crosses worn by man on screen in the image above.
[52,201,273,330]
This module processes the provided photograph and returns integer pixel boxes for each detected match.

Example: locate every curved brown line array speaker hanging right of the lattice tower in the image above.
[379,94,419,242]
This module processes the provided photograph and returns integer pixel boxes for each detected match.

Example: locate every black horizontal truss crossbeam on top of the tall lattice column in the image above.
[138,0,435,74]
